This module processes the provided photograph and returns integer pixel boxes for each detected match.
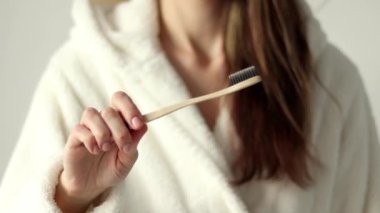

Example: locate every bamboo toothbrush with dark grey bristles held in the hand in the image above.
[143,66,261,122]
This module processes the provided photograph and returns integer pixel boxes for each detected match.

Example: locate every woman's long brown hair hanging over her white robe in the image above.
[225,0,312,187]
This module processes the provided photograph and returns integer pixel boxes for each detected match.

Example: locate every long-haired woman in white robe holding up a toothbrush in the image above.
[0,0,380,213]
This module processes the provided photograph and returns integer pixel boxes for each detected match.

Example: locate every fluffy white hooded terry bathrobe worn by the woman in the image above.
[0,0,380,213]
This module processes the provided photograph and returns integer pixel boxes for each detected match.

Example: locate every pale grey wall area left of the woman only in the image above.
[0,0,71,181]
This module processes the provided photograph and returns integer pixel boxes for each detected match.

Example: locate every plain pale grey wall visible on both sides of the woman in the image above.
[0,0,380,183]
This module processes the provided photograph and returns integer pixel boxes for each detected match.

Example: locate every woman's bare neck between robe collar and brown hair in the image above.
[159,0,226,58]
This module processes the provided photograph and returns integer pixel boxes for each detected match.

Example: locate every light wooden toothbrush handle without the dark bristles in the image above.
[143,76,261,122]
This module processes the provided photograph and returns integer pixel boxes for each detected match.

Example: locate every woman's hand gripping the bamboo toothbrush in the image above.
[55,92,147,212]
